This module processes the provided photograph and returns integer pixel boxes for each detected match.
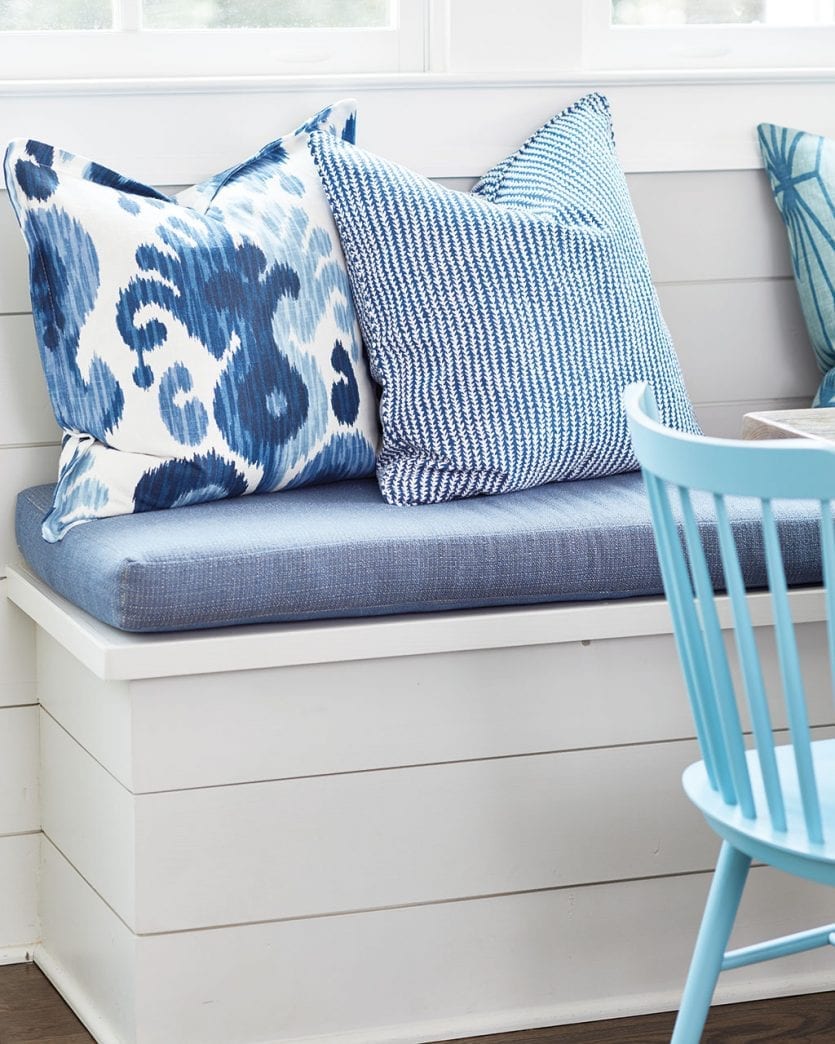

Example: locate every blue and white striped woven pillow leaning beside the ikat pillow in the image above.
[310,96,697,504]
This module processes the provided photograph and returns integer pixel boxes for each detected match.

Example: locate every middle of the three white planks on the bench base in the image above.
[42,714,828,933]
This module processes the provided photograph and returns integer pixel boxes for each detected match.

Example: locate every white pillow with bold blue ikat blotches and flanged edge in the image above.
[5,101,378,541]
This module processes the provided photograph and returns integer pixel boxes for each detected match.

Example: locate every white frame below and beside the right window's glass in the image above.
[582,0,835,71]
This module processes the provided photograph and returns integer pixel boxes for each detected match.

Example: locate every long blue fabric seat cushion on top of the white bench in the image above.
[17,473,820,632]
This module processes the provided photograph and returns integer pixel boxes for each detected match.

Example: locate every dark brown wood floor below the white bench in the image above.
[0,965,835,1044]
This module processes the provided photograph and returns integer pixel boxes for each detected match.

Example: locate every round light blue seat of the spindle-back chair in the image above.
[682,739,835,884]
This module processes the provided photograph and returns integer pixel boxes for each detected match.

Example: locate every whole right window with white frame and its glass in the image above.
[583,0,835,69]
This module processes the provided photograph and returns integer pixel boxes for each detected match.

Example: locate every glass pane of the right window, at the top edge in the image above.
[612,0,835,25]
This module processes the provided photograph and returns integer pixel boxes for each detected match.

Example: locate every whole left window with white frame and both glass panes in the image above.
[0,0,428,79]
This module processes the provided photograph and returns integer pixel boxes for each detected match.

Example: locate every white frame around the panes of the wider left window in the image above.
[0,0,429,81]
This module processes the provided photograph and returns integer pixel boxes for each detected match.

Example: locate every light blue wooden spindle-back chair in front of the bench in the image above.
[624,384,835,1044]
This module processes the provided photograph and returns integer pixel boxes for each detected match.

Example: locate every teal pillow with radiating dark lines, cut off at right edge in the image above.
[757,123,835,406]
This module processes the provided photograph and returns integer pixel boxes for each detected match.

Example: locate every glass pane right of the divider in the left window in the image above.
[142,0,391,29]
